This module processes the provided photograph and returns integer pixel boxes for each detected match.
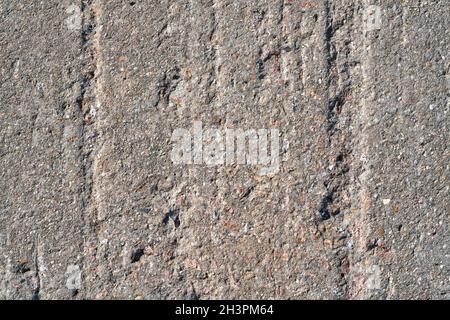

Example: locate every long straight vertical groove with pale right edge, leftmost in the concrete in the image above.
[79,0,105,297]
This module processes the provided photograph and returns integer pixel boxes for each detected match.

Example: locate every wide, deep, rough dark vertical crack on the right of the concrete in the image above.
[318,0,354,299]
